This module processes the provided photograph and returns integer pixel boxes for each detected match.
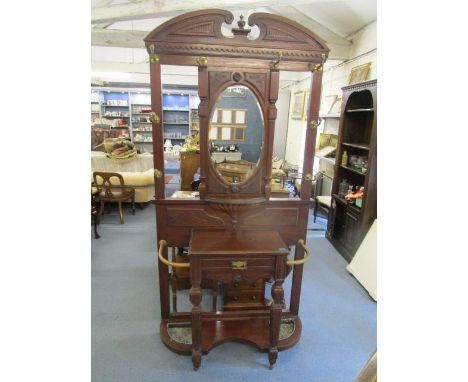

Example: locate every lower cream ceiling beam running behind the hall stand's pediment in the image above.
[91,28,349,60]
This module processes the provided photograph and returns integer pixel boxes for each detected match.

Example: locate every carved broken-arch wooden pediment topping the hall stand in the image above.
[145,9,329,62]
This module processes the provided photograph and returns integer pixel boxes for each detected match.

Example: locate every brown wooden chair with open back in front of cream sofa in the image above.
[93,171,135,224]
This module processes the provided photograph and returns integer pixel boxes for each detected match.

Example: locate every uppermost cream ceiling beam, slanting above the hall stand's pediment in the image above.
[91,0,323,24]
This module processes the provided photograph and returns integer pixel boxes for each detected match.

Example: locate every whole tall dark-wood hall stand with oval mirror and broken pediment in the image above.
[145,9,329,369]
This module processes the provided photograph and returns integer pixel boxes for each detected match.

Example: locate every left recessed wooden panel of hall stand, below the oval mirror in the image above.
[167,207,225,227]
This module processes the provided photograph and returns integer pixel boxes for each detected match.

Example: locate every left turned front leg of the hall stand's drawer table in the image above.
[190,261,202,370]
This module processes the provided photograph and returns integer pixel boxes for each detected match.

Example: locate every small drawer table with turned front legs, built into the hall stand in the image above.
[189,229,289,370]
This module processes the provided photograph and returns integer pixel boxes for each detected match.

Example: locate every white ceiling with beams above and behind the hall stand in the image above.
[91,0,377,87]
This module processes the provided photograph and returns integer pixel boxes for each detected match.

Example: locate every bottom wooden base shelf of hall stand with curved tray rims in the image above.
[160,317,302,355]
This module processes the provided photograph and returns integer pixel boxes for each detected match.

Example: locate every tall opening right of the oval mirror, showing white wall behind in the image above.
[271,71,311,198]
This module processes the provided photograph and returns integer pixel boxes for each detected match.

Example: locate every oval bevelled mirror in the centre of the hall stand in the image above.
[208,85,265,183]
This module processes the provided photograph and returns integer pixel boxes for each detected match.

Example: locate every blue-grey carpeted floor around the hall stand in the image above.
[92,205,377,382]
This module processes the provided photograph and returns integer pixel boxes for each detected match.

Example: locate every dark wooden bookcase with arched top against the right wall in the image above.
[326,80,377,262]
